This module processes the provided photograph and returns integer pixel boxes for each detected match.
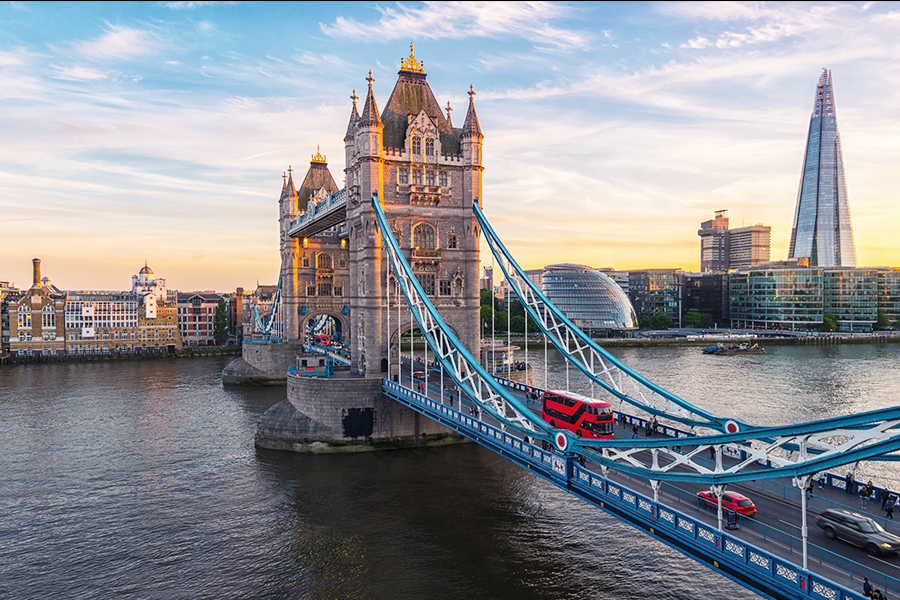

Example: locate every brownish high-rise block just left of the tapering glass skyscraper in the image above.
[697,210,772,273]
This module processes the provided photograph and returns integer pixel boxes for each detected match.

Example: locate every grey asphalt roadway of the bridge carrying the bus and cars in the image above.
[403,360,900,597]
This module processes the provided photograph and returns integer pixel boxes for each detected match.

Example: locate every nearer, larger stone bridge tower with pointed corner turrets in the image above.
[344,45,483,377]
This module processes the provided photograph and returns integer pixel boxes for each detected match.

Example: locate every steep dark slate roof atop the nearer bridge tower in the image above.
[381,71,459,154]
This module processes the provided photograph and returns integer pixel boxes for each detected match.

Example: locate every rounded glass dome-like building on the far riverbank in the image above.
[541,264,638,337]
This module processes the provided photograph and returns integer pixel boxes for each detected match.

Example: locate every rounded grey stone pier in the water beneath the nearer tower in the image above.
[255,375,466,454]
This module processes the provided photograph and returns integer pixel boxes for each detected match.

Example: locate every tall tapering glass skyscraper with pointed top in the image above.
[789,69,856,267]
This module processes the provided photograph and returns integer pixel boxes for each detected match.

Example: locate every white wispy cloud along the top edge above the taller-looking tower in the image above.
[319,2,587,47]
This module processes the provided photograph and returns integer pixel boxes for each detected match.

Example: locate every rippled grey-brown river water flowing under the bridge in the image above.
[0,344,900,600]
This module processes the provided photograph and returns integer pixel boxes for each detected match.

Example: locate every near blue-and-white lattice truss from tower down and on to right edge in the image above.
[373,197,900,485]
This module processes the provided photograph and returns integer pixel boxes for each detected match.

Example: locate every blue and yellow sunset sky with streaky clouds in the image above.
[0,2,900,292]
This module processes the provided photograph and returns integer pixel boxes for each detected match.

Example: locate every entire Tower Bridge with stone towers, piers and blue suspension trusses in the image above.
[229,48,900,599]
